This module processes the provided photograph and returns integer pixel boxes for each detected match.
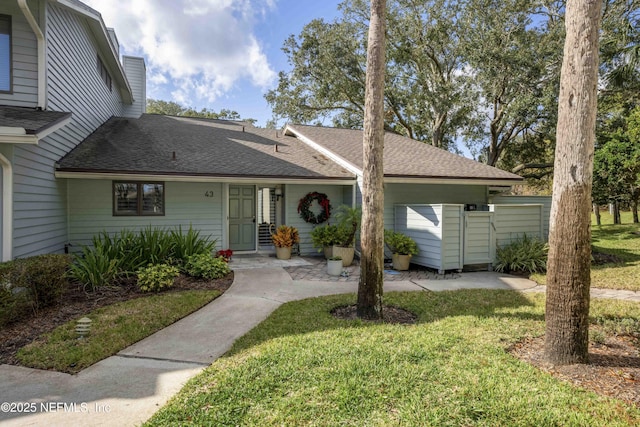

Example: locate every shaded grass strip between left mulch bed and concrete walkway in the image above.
[17,291,220,373]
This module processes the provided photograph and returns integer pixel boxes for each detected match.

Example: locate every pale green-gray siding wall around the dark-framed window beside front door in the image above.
[68,179,224,250]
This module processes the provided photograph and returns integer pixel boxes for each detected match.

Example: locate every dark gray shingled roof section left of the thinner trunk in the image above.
[56,114,355,180]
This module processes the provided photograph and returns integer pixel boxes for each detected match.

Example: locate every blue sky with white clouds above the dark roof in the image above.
[83,0,348,126]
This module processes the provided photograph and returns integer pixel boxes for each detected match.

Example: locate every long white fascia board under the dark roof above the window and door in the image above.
[55,171,355,185]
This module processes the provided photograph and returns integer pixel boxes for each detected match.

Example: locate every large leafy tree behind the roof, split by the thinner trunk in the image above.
[265,0,474,148]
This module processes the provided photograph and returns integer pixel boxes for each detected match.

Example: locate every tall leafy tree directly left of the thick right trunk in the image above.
[460,0,562,166]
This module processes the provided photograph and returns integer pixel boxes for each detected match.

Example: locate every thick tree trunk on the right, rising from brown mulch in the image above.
[544,0,601,365]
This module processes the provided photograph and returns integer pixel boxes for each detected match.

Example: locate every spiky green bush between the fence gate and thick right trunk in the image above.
[493,234,549,273]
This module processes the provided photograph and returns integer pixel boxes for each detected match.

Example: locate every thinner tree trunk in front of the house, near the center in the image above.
[357,0,386,319]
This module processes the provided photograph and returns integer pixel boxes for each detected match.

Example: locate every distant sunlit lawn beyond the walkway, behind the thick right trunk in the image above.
[531,216,640,291]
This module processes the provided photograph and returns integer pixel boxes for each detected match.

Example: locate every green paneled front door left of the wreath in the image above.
[229,185,257,251]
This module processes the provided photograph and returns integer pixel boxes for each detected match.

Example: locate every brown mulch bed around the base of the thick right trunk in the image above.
[510,335,640,407]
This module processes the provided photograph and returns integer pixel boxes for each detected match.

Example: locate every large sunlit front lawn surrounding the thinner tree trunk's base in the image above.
[146,290,640,426]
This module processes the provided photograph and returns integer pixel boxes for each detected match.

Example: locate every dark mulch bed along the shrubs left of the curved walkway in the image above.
[0,273,233,365]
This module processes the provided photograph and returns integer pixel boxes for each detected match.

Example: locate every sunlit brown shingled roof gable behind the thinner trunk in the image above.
[285,125,522,184]
